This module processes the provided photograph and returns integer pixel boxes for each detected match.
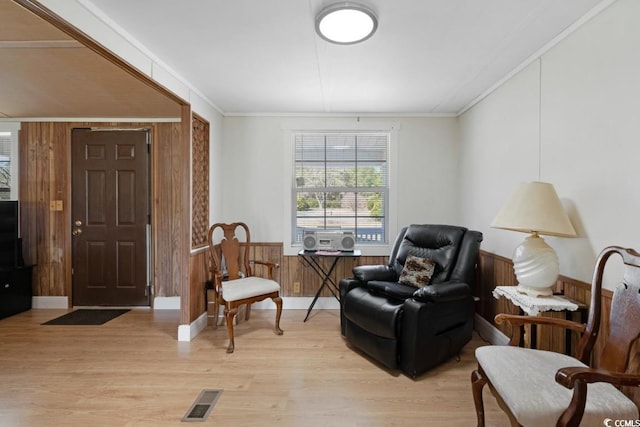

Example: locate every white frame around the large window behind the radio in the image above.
[282,119,399,256]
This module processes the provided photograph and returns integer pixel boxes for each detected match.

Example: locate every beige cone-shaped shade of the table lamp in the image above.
[491,182,576,237]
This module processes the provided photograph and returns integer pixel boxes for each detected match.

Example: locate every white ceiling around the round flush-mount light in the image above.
[80,0,603,115]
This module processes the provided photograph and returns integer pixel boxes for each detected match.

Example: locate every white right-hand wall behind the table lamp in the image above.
[459,0,640,287]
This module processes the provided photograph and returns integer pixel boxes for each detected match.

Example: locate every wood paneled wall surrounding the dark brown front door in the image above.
[20,118,191,317]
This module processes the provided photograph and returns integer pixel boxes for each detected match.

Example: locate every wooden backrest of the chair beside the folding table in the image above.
[208,222,253,280]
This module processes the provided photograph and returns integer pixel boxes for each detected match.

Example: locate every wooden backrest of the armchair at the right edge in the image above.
[577,246,640,372]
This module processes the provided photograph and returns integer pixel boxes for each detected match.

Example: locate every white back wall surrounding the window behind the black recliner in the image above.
[219,117,459,255]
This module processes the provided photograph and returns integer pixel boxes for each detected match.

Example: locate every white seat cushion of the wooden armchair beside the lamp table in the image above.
[476,346,638,427]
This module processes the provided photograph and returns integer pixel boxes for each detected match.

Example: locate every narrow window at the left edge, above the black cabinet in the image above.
[0,123,18,200]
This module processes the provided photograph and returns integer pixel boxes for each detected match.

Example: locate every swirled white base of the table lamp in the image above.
[513,233,560,296]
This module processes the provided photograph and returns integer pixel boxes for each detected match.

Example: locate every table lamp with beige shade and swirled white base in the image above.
[491,182,576,297]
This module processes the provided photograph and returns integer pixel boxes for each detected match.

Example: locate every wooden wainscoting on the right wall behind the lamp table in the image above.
[476,251,613,357]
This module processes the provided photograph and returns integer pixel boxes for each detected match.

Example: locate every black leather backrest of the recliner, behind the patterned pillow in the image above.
[390,224,475,283]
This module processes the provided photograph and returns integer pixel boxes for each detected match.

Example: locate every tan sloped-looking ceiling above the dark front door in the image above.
[0,0,182,119]
